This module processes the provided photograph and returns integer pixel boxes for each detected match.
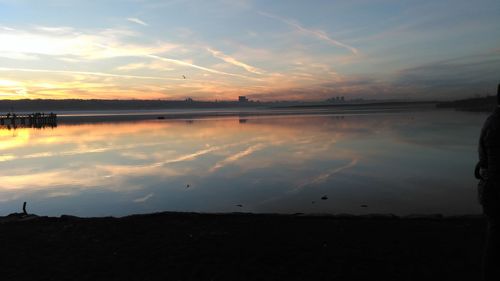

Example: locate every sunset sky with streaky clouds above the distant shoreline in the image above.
[0,0,500,101]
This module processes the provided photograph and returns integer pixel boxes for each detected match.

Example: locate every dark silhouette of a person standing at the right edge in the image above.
[474,84,500,280]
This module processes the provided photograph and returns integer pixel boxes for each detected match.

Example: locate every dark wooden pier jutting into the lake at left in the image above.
[0,112,57,129]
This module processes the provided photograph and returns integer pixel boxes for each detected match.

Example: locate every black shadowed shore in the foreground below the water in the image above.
[0,213,485,280]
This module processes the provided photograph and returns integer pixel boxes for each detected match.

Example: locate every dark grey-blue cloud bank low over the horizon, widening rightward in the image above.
[247,47,500,100]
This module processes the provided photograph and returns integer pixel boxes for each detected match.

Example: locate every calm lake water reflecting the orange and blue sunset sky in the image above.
[0,108,486,216]
